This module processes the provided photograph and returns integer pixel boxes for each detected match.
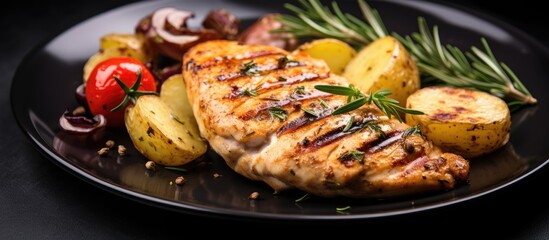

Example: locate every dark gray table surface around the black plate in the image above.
[0,0,549,239]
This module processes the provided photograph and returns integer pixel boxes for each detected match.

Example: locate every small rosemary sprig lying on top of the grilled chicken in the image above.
[315,85,423,122]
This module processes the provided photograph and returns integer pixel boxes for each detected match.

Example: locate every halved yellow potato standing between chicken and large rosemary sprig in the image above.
[343,36,420,107]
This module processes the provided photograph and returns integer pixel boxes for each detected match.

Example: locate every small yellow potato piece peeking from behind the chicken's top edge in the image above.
[294,38,356,75]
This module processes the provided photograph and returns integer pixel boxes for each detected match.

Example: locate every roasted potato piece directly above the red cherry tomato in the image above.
[82,33,153,82]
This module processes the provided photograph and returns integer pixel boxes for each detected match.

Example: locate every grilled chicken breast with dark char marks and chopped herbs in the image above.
[183,40,469,198]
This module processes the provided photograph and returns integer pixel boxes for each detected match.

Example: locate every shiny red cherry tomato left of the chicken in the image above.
[86,57,156,127]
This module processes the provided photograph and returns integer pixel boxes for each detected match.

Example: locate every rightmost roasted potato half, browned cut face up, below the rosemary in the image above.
[406,86,511,158]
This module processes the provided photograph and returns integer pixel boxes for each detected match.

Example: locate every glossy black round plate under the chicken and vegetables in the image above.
[11,0,549,220]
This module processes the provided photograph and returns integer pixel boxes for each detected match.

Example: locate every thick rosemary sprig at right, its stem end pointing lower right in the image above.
[393,17,537,110]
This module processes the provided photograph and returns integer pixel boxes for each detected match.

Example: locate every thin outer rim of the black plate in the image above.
[9,0,549,221]
